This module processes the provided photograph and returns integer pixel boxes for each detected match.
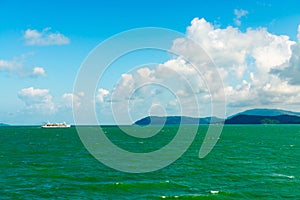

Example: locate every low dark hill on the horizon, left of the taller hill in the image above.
[134,116,224,126]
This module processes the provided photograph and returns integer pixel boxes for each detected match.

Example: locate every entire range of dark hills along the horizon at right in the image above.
[134,108,300,126]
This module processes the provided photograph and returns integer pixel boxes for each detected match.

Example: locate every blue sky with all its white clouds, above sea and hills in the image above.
[0,0,300,125]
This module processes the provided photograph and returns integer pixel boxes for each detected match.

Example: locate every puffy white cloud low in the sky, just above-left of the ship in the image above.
[18,87,56,114]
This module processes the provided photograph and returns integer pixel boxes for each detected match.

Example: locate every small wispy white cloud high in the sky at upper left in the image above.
[24,28,70,46]
